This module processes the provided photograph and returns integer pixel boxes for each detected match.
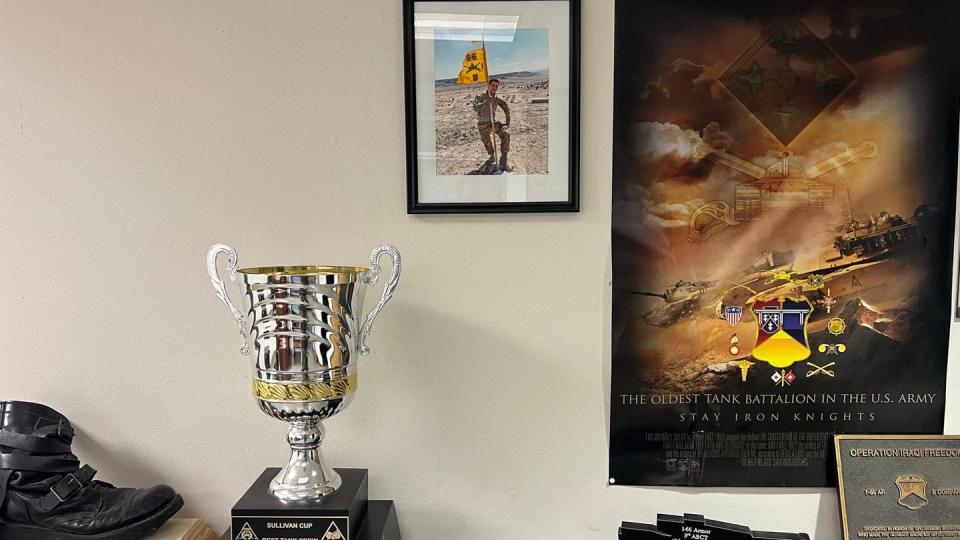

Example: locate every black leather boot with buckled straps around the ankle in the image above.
[0,401,183,540]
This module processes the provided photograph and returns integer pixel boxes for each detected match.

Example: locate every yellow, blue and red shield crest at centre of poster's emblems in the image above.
[751,297,813,368]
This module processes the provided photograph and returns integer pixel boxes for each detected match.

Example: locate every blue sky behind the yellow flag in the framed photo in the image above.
[433,28,550,80]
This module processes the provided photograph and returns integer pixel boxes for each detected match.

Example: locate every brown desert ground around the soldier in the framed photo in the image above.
[436,71,550,175]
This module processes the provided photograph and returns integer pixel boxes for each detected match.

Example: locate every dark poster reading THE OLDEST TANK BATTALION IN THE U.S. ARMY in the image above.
[610,0,960,486]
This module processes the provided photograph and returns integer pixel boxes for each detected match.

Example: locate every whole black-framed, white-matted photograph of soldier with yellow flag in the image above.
[404,0,580,214]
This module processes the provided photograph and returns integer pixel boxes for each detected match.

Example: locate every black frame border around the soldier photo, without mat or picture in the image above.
[403,0,580,214]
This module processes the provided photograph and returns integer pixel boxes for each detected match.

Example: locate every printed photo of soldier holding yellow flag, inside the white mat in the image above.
[434,29,550,175]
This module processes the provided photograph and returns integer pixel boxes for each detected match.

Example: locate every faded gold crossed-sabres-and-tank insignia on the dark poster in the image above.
[687,141,877,242]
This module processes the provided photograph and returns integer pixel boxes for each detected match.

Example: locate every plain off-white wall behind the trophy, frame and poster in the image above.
[0,0,958,540]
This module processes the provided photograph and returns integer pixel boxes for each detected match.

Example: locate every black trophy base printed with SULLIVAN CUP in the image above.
[229,468,382,540]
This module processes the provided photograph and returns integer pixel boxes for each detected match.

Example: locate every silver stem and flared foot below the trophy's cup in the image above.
[270,418,341,501]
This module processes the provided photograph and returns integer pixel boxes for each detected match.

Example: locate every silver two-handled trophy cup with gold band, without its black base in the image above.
[207,244,400,501]
